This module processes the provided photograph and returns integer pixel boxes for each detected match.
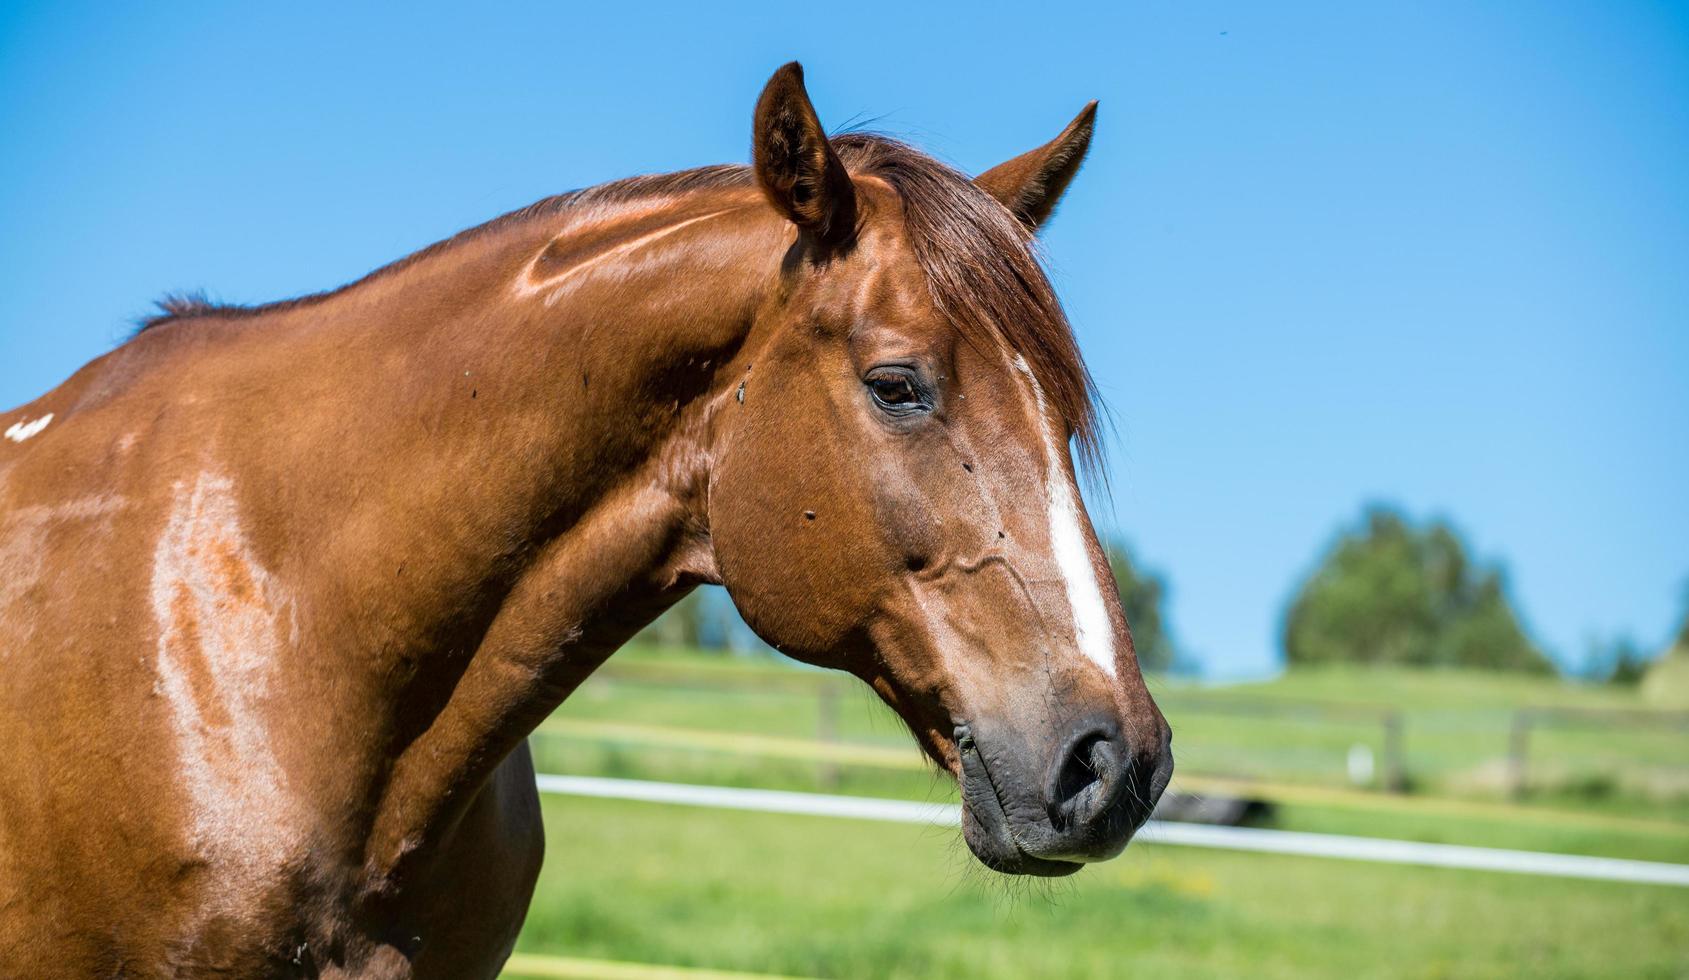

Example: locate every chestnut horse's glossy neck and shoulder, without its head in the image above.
[0,184,777,966]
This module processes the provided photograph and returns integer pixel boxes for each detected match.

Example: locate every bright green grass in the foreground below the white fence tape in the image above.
[519,799,1689,978]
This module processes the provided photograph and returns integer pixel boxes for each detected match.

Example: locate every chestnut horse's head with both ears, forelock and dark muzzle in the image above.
[709,64,1172,875]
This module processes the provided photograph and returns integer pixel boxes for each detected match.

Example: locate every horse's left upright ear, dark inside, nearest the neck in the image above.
[750,61,856,245]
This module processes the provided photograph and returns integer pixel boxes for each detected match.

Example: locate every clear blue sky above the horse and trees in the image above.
[0,0,1689,676]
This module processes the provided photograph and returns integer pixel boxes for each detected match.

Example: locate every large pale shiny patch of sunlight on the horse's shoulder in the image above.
[152,473,299,878]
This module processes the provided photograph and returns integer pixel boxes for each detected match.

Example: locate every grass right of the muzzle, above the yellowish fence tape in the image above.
[1159,667,1689,818]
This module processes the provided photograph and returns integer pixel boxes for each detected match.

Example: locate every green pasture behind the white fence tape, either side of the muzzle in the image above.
[534,649,1689,862]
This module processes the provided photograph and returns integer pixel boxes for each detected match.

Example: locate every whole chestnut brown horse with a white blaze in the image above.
[0,64,1172,978]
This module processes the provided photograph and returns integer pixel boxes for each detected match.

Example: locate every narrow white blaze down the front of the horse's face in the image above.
[1015,353,1115,678]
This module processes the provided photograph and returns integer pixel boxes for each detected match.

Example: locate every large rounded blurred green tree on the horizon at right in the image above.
[1284,507,1554,674]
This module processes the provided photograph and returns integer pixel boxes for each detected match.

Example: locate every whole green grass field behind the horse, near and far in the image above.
[503,651,1689,977]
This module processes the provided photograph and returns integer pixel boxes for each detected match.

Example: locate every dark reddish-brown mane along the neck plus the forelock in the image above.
[137,132,1101,473]
